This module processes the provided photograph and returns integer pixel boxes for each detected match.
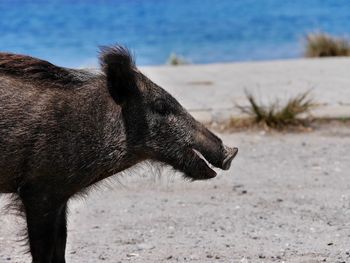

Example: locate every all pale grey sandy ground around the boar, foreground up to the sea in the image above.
[0,58,350,263]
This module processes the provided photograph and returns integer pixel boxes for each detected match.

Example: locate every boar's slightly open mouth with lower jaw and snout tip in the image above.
[175,148,238,180]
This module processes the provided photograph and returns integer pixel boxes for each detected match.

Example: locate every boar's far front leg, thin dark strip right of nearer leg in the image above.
[52,204,67,263]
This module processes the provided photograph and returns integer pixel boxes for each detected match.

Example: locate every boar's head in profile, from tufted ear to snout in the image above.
[100,46,238,180]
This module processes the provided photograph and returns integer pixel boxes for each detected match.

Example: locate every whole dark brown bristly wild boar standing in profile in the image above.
[0,46,237,263]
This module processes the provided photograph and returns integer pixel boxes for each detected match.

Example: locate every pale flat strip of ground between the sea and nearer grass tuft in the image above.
[141,58,350,122]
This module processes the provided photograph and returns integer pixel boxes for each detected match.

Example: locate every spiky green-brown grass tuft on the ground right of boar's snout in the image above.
[237,92,316,129]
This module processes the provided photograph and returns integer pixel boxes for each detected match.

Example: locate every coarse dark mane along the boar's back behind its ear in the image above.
[0,53,94,87]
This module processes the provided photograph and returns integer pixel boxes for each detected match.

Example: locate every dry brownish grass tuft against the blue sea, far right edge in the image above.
[305,32,350,57]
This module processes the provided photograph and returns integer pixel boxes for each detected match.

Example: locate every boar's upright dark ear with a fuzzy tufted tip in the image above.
[100,46,136,103]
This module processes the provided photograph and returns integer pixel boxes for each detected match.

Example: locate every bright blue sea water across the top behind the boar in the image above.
[0,0,350,67]
